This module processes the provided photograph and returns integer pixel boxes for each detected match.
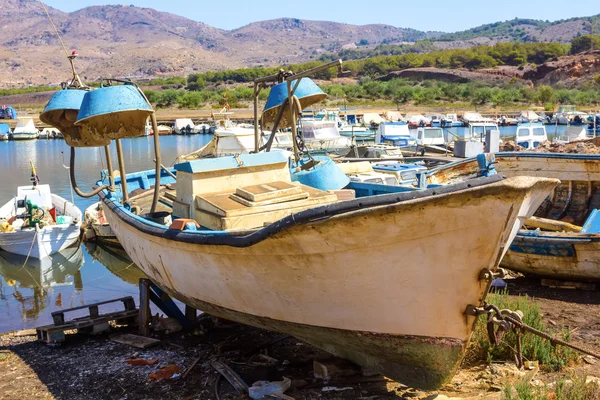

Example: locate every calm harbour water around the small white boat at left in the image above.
[0,135,211,332]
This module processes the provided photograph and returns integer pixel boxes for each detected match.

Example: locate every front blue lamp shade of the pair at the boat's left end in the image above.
[75,85,154,147]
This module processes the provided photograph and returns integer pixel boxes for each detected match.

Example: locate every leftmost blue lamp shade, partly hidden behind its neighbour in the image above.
[40,89,86,147]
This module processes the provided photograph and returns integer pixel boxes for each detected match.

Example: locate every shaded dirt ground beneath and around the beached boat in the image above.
[0,278,600,400]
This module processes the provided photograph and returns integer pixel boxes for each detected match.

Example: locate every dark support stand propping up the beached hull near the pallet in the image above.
[139,278,196,336]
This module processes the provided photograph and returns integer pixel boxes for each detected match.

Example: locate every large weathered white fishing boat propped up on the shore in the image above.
[41,62,558,388]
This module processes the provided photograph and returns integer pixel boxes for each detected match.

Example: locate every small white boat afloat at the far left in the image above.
[0,178,81,258]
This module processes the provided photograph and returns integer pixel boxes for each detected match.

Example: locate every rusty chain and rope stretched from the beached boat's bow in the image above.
[467,303,600,362]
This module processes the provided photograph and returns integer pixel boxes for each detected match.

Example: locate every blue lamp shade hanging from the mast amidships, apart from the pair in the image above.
[262,78,327,129]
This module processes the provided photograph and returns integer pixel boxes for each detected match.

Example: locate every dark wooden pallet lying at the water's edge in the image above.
[36,296,139,343]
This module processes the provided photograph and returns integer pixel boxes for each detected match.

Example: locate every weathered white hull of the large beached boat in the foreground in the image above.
[104,177,557,388]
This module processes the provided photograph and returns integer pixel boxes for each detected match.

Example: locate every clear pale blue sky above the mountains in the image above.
[45,0,600,32]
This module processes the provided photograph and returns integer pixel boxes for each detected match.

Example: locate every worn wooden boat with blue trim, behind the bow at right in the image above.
[429,152,600,281]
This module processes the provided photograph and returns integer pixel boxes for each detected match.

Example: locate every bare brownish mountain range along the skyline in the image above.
[0,0,597,87]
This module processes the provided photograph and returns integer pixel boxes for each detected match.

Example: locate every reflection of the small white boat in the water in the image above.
[0,244,84,320]
